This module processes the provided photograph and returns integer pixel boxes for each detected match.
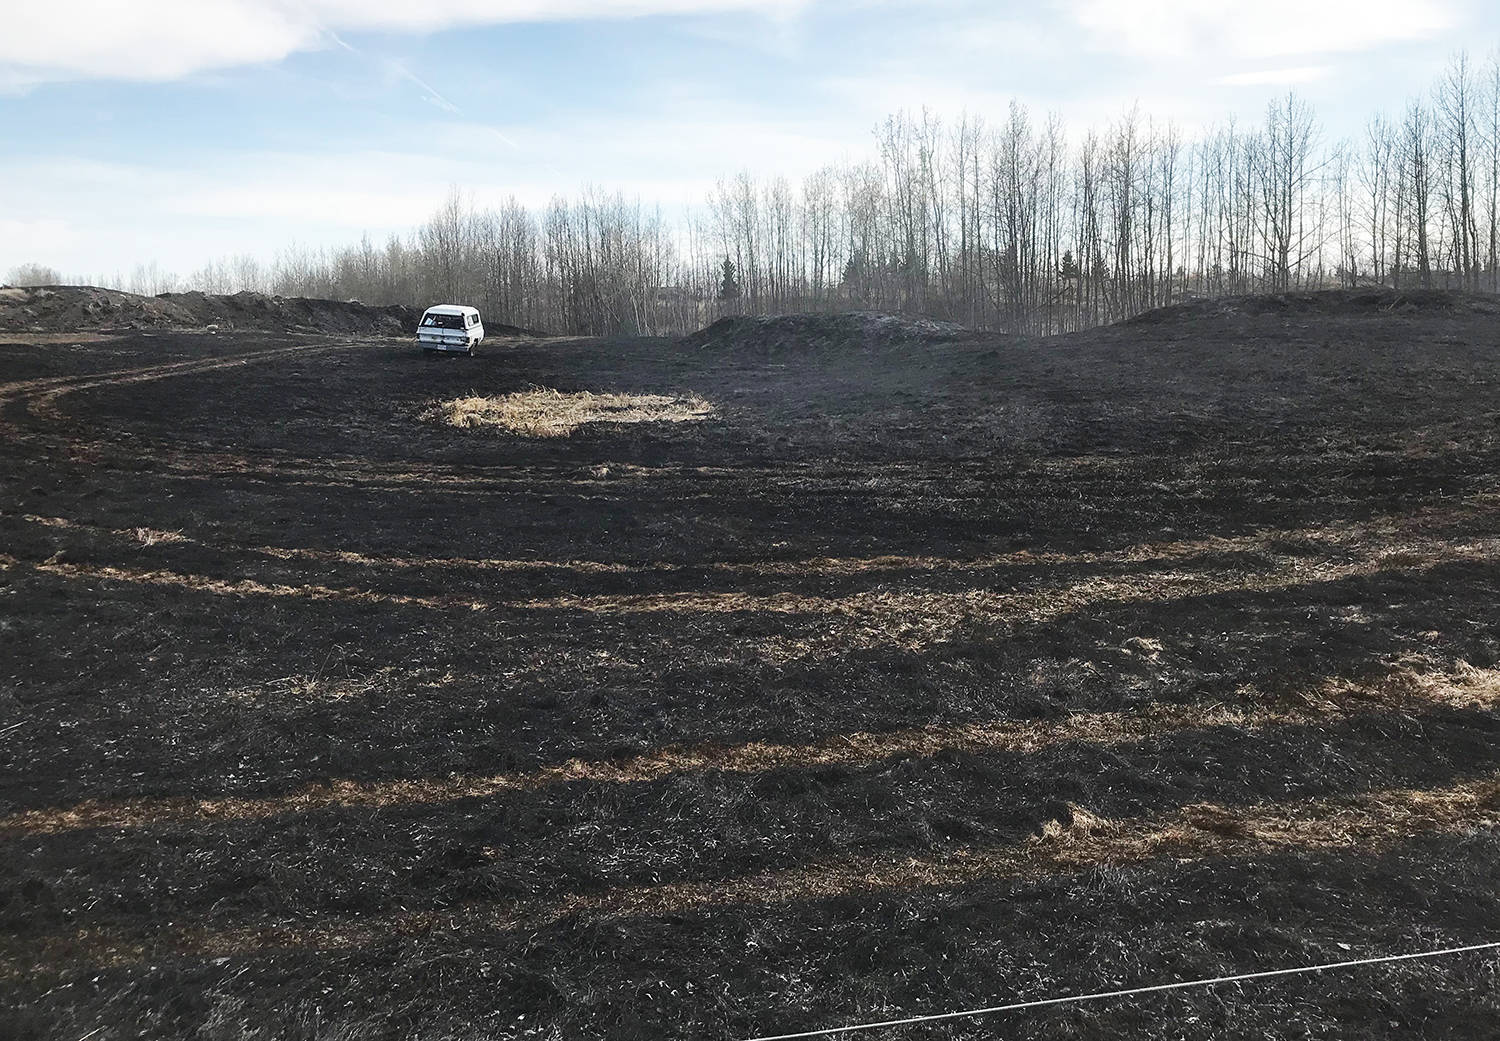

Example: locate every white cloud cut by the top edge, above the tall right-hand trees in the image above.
[1062,0,1455,59]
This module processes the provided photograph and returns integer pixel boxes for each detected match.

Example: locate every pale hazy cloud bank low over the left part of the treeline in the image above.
[0,96,869,278]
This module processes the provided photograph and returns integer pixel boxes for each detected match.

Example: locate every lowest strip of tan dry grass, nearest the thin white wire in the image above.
[11,773,1500,978]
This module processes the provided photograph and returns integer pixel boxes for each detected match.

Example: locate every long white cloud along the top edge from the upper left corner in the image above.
[0,0,803,92]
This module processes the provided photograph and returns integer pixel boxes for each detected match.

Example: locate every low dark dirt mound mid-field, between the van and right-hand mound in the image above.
[684,311,977,354]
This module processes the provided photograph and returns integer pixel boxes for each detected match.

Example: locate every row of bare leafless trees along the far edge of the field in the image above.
[58,54,1500,333]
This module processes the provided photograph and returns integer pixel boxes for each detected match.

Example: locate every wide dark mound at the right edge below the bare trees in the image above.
[1119,288,1500,326]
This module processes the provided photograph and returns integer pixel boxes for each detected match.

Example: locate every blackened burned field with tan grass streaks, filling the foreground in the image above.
[0,296,1500,1040]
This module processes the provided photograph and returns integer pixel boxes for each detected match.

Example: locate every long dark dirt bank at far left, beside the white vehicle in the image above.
[0,285,420,335]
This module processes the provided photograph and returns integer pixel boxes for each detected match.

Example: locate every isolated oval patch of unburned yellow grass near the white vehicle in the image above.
[423,387,714,438]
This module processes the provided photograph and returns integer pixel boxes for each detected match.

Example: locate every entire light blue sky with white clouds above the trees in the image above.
[0,0,1500,276]
